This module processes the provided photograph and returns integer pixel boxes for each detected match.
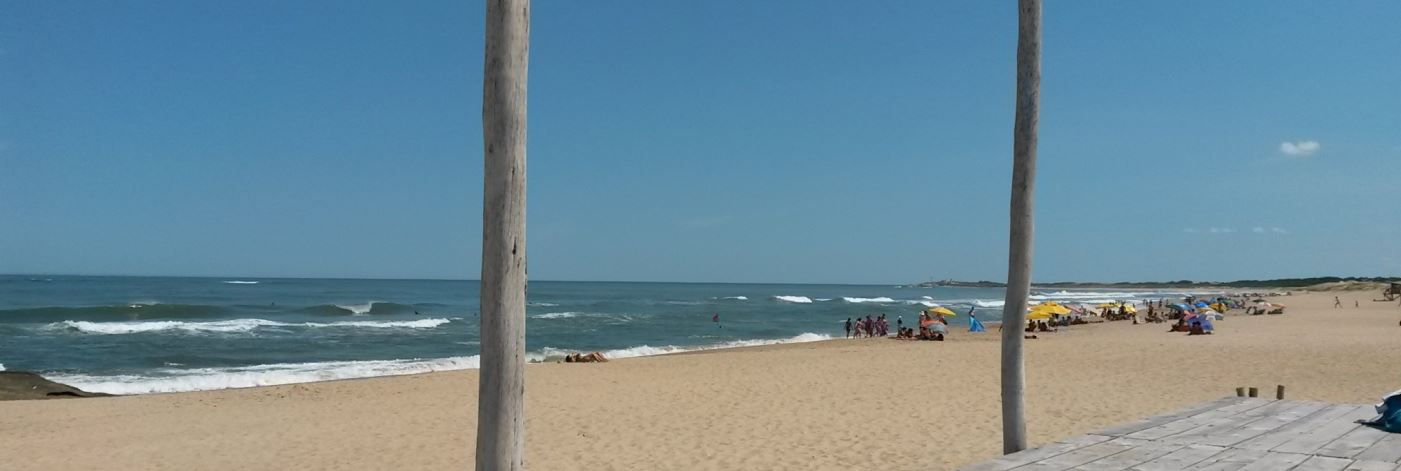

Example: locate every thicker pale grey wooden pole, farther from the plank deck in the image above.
[476,0,530,471]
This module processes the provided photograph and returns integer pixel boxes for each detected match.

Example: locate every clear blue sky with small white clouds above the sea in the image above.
[0,0,1401,283]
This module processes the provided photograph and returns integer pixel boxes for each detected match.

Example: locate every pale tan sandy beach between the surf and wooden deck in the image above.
[0,292,1401,470]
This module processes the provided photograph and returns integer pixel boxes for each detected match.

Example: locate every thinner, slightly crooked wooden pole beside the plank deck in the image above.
[1002,0,1041,453]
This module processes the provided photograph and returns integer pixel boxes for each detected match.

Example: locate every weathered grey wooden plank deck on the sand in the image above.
[960,397,1401,471]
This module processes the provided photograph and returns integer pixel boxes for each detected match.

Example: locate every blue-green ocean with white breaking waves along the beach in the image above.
[0,275,1180,394]
